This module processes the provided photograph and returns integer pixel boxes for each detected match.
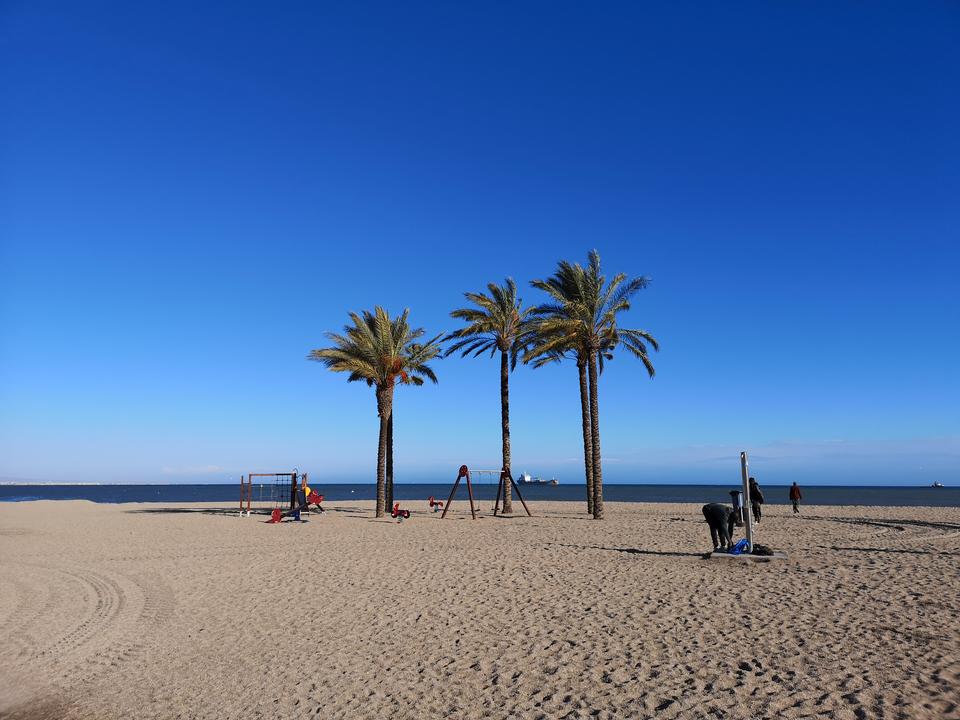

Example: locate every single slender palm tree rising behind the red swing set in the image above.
[444,278,532,513]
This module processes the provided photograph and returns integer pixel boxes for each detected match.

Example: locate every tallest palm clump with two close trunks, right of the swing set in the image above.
[524,250,659,520]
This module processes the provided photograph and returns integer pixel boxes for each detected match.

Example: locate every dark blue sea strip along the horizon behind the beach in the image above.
[0,482,960,509]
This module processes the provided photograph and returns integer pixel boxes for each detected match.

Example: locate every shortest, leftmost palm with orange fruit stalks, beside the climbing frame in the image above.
[307,305,440,517]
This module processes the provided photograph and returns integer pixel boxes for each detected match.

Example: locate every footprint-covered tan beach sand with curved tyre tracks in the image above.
[0,501,960,720]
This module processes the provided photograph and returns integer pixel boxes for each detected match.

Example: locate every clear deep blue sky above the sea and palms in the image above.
[0,1,960,484]
